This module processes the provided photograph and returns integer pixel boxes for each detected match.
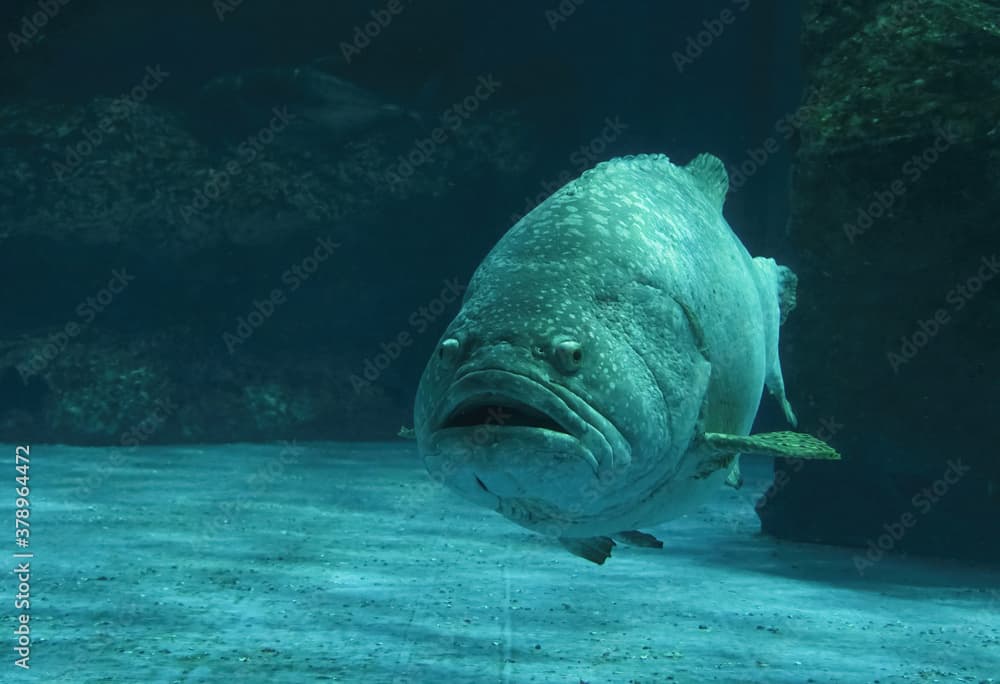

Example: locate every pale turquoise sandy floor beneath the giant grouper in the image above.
[0,443,1000,684]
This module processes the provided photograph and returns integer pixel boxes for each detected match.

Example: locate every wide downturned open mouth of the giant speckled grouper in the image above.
[430,369,629,474]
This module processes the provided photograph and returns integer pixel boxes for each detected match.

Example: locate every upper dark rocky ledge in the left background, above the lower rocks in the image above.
[0,93,505,258]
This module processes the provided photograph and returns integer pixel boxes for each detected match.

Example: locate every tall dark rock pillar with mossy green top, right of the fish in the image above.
[758,0,1000,572]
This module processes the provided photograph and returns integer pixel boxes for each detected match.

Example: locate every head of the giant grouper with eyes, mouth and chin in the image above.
[414,272,696,536]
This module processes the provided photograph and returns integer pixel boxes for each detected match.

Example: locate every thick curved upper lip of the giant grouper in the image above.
[430,368,624,474]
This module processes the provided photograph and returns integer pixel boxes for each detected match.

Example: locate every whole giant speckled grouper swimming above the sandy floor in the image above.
[404,154,840,563]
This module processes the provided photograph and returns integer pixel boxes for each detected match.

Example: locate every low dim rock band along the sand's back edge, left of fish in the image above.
[0,327,406,448]
